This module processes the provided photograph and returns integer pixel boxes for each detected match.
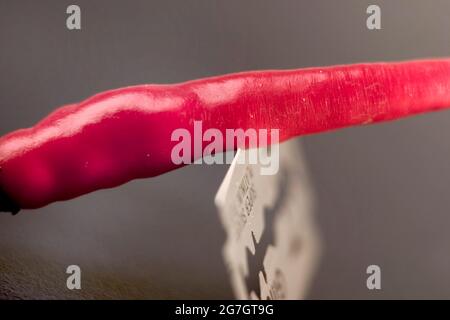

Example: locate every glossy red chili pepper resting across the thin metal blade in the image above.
[0,59,450,208]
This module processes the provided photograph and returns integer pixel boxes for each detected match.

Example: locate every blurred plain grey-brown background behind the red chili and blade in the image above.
[0,0,450,298]
